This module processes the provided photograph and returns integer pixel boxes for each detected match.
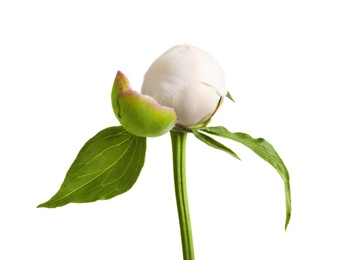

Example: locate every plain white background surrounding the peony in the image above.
[0,0,352,260]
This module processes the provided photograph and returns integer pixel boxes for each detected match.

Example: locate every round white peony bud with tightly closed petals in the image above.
[141,45,227,128]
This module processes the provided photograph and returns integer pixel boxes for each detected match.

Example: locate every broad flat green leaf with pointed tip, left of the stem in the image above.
[38,126,146,208]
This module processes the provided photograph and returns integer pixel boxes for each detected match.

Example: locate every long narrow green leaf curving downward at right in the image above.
[199,126,291,229]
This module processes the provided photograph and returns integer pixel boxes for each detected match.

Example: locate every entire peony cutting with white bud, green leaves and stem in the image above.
[38,45,291,260]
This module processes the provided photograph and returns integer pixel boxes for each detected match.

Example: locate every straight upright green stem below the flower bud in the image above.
[170,131,194,260]
